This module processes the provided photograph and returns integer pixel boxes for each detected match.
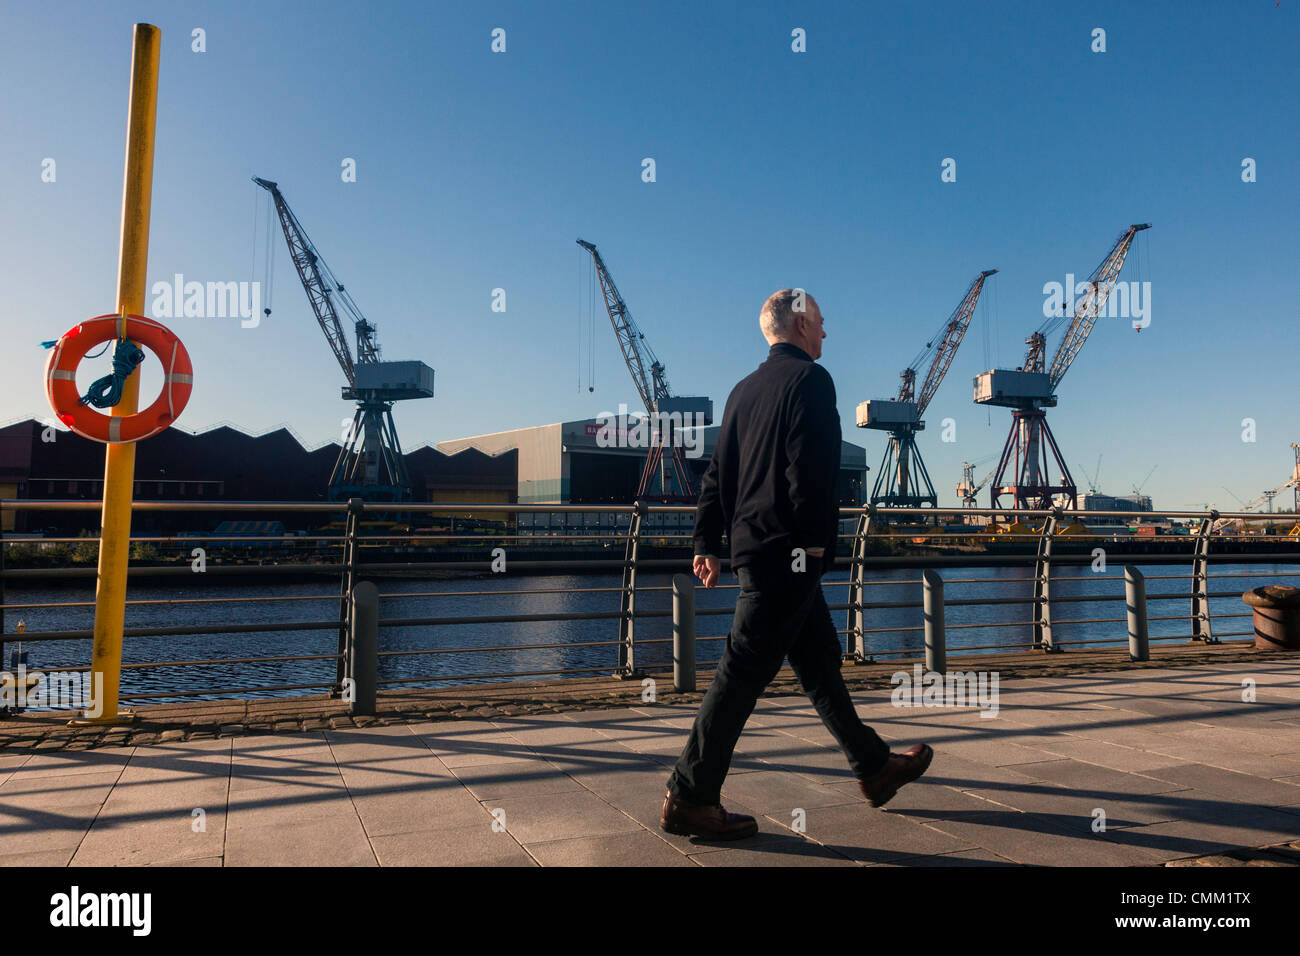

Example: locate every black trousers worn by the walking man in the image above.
[668,562,889,804]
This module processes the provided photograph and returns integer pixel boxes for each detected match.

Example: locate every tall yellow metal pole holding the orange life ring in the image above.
[73,23,163,723]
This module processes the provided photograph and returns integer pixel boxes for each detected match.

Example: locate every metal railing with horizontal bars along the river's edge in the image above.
[0,499,1300,701]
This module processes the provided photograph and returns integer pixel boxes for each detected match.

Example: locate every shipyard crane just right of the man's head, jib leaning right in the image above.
[857,269,997,507]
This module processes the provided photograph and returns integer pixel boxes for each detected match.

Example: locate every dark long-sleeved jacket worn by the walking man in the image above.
[694,342,840,572]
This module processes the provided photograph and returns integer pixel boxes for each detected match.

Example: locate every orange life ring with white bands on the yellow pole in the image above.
[46,315,194,442]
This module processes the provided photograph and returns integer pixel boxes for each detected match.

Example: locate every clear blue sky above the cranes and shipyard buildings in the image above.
[0,0,1300,507]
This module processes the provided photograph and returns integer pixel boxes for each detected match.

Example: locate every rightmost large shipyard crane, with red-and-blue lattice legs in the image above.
[975,222,1151,510]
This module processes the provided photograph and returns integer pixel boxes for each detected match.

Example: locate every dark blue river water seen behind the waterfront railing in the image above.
[4,563,1300,704]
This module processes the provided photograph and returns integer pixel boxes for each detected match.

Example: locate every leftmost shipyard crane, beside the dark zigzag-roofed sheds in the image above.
[254,177,433,501]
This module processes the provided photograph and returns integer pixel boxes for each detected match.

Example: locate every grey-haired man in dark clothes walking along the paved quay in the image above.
[660,289,935,840]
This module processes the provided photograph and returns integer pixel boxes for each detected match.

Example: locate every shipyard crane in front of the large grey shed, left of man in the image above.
[577,239,714,501]
